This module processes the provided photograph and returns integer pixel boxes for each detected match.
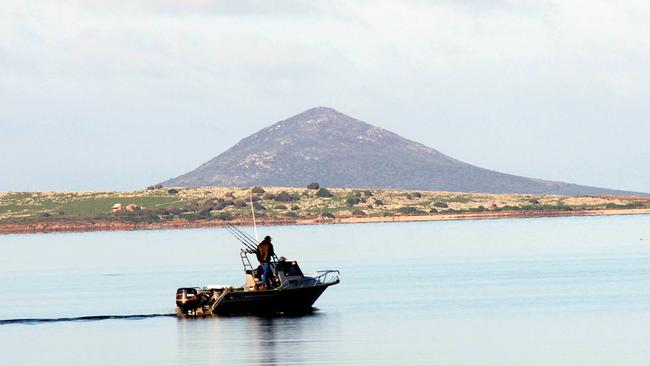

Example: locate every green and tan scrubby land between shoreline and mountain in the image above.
[0,187,650,233]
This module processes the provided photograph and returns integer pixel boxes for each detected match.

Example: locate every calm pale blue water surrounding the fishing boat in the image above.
[0,216,650,365]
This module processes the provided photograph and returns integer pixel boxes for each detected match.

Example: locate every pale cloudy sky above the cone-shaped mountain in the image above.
[0,0,650,192]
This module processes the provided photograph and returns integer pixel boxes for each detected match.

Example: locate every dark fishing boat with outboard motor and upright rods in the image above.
[176,225,340,316]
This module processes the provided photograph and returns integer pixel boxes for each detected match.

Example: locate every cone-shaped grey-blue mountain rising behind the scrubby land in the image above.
[162,107,638,195]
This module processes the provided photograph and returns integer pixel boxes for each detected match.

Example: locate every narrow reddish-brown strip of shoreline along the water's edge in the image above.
[0,208,650,235]
